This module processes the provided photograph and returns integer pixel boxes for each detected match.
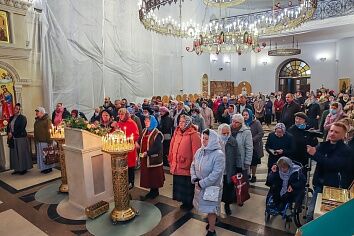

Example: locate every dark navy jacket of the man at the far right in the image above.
[312,141,354,188]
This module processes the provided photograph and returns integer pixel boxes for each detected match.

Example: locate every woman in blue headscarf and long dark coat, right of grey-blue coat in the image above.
[242,108,264,183]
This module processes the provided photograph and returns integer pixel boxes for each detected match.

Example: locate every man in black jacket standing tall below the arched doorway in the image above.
[280,93,300,129]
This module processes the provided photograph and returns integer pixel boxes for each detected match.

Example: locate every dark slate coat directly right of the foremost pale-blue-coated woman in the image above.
[224,136,239,183]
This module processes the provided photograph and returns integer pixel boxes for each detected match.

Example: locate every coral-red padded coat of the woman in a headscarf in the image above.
[168,125,202,176]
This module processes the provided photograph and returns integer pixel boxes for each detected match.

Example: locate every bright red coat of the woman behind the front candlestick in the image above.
[117,118,139,167]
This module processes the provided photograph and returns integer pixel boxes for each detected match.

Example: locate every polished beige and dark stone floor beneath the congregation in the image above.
[0,124,306,236]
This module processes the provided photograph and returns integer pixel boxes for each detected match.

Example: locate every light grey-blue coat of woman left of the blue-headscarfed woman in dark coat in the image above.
[231,125,253,170]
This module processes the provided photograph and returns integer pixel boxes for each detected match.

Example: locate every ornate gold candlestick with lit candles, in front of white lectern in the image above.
[102,131,138,223]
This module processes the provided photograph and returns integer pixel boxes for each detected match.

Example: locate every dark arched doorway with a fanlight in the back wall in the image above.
[277,58,311,94]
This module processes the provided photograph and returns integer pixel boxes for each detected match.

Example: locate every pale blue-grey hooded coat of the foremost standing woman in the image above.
[190,130,225,214]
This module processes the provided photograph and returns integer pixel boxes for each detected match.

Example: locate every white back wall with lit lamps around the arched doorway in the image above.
[183,38,354,93]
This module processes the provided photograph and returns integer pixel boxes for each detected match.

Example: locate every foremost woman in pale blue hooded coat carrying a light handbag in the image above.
[190,129,225,235]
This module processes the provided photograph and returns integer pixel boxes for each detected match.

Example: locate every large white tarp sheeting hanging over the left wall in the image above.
[41,0,195,112]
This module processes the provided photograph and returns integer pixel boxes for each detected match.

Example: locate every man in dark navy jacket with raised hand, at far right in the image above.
[307,122,354,220]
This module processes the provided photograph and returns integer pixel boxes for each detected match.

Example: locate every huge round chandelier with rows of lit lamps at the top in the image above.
[139,0,317,55]
